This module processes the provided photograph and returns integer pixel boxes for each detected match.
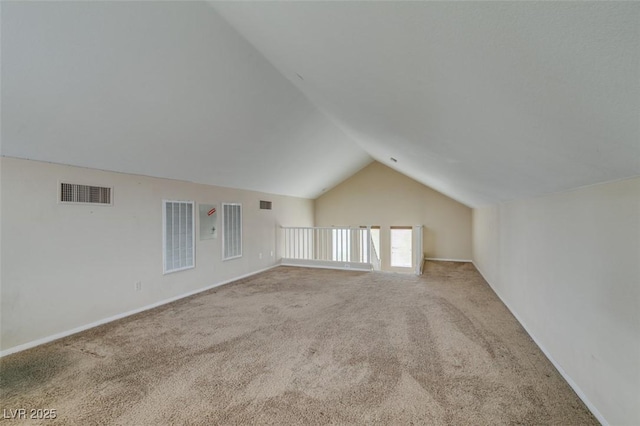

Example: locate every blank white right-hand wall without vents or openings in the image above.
[473,177,640,425]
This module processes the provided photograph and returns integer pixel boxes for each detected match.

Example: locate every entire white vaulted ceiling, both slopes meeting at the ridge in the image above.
[2,1,640,206]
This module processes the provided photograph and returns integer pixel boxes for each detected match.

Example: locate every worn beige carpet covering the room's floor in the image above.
[0,262,598,425]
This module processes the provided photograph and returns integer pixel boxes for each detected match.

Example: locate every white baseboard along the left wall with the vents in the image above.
[0,264,280,358]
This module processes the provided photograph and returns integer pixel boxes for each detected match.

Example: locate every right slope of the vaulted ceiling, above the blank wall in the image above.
[213,1,640,206]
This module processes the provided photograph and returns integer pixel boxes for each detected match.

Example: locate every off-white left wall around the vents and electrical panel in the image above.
[0,157,314,351]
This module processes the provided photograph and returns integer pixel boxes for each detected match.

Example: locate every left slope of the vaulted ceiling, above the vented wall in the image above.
[1,1,371,198]
